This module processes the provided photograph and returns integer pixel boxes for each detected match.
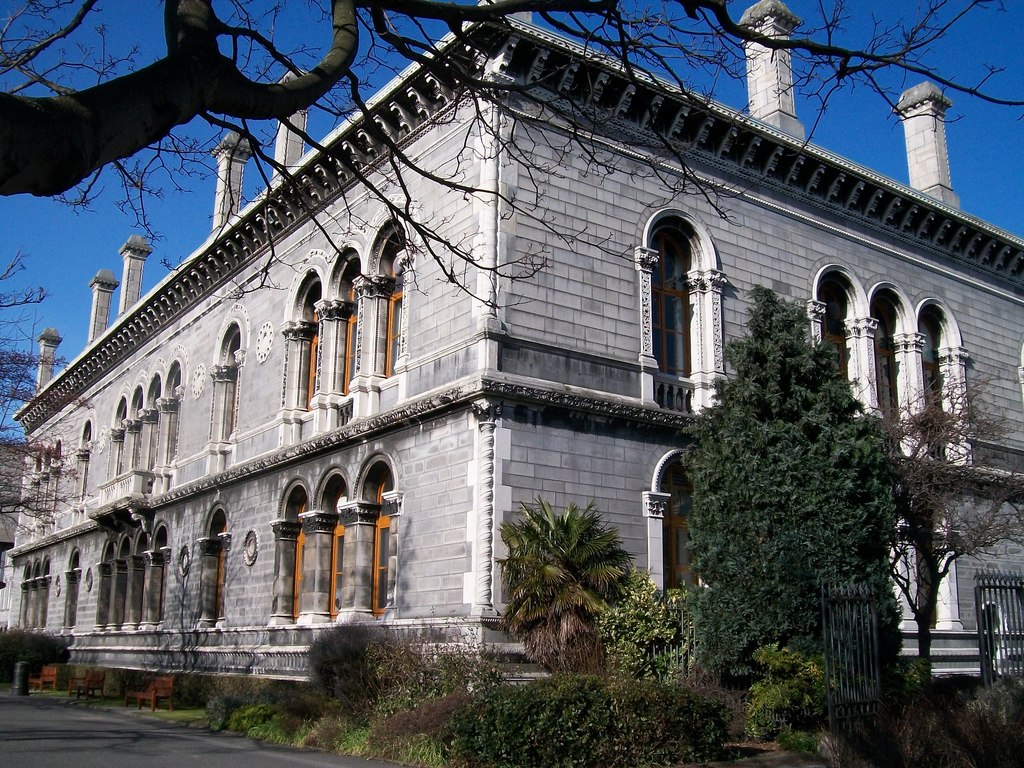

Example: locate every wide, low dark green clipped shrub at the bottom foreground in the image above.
[452,676,726,768]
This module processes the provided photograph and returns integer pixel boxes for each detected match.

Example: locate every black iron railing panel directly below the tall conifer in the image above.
[821,585,882,730]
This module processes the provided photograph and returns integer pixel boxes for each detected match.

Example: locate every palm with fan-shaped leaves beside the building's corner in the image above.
[499,499,630,672]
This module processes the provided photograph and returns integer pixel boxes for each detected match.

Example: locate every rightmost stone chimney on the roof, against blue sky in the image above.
[896,81,959,207]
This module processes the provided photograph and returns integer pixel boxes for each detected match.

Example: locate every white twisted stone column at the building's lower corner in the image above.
[472,400,502,615]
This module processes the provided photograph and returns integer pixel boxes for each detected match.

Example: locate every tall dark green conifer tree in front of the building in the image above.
[687,287,898,675]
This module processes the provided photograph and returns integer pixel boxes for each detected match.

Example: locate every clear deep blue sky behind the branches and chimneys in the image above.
[0,0,1024,370]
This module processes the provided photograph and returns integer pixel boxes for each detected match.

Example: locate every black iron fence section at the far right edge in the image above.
[974,571,1024,685]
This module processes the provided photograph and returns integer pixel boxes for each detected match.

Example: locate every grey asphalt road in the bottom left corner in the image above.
[0,692,396,768]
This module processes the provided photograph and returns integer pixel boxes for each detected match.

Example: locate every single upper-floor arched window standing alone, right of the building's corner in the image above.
[651,227,692,376]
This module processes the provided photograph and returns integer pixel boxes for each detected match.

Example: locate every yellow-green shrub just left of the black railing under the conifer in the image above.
[746,645,827,738]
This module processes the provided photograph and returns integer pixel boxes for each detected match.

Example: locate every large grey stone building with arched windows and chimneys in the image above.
[10,6,1024,675]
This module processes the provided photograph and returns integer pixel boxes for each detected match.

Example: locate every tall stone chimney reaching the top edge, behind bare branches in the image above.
[739,0,805,139]
